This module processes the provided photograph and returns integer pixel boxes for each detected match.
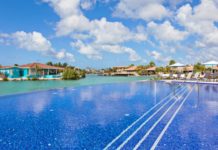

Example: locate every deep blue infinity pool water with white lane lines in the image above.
[0,81,218,150]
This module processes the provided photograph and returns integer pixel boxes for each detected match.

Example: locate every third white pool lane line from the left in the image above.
[133,85,192,150]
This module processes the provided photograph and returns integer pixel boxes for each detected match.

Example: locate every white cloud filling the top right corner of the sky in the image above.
[176,0,218,47]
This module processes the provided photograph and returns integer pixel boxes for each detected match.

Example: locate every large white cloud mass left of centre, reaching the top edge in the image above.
[43,0,147,61]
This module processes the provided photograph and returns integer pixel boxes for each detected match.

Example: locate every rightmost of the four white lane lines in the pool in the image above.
[151,88,193,150]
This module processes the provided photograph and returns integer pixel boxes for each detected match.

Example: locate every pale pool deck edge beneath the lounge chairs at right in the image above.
[160,80,218,85]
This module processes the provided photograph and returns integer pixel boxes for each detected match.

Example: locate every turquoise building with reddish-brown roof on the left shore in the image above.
[0,63,64,79]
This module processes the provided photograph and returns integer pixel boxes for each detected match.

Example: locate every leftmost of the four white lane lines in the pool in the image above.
[103,84,186,150]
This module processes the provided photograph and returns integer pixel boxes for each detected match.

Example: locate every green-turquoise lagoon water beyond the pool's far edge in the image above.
[0,75,150,95]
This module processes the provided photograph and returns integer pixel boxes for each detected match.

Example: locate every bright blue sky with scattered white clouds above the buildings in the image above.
[0,0,218,68]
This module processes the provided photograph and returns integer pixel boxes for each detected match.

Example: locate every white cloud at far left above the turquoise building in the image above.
[0,31,74,61]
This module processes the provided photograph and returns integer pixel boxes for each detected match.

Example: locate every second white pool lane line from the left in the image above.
[117,87,185,150]
